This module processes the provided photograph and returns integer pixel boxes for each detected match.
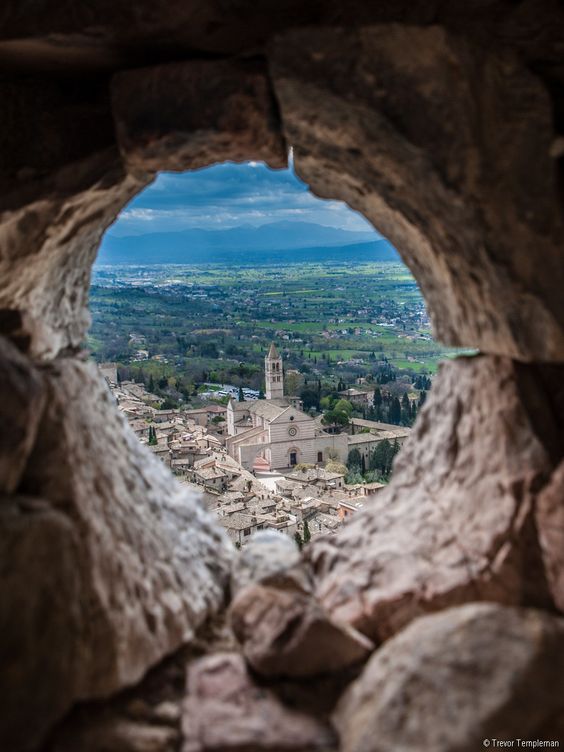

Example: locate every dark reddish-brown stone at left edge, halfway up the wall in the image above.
[0,337,45,493]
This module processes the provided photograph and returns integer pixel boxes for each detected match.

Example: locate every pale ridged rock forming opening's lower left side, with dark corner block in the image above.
[0,358,233,749]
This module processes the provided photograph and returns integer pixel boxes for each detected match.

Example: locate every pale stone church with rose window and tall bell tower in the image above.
[226,344,348,470]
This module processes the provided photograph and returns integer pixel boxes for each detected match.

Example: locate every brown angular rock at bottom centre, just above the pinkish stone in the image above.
[230,585,374,677]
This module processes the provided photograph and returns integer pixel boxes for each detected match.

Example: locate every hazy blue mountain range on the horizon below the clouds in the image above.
[97,222,398,265]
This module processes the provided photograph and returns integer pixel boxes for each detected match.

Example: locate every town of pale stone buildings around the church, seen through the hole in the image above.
[100,343,410,547]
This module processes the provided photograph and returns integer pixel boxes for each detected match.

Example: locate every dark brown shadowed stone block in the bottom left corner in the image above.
[0,496,82,752]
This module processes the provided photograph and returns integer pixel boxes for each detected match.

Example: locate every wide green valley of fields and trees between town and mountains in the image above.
[88,260,451,396]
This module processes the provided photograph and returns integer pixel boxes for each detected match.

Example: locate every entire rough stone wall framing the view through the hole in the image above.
[0,0,564,752]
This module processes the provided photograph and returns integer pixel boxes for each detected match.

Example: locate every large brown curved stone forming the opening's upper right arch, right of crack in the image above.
[271,25,564,360]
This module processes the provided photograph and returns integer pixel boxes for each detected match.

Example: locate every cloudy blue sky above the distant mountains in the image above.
[109,162,378,237]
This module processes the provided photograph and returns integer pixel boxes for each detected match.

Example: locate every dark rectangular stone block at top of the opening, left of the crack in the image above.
[112,61,286,171]
